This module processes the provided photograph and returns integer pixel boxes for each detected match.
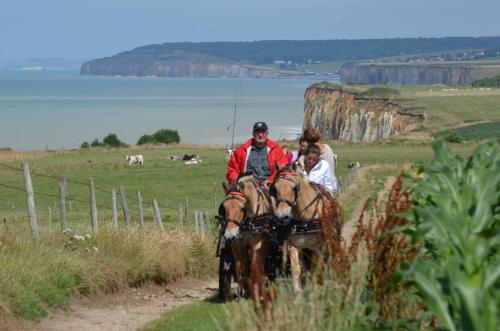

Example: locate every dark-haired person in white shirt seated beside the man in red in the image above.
[304,145,337,193]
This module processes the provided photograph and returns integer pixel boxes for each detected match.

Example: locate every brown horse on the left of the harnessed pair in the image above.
[221,176,272,296]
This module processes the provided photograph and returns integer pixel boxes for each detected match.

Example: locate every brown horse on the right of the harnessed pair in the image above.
[273,169,337,291]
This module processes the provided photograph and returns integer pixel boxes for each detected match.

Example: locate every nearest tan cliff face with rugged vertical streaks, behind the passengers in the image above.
[303,87,424,142]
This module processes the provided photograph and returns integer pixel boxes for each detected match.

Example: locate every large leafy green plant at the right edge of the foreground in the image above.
[408,141,500,331]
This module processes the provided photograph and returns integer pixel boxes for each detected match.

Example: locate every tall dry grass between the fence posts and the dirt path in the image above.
[0,228,216,320]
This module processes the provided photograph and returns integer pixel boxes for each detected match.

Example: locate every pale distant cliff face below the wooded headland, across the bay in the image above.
[80,60,289,78]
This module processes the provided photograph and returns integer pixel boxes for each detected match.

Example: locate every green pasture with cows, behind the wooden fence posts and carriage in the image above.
[0,142,475,237]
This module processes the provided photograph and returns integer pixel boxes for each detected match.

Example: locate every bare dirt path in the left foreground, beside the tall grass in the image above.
[25,279,217,331]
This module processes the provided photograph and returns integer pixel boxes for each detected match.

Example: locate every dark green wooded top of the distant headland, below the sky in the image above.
[86,37,500,64]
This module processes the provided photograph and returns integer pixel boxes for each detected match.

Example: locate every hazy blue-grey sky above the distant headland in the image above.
[0,0,500,60]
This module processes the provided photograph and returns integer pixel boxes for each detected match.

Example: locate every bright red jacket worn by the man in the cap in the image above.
[226,139,288,183]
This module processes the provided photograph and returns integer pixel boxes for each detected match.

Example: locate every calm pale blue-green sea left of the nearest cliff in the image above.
[0,71,334,150]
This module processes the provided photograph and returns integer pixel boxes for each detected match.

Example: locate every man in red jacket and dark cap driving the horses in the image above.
[226,122,288,185]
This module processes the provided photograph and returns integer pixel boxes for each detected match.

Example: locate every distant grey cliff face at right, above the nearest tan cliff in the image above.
[340,64,472,85]
